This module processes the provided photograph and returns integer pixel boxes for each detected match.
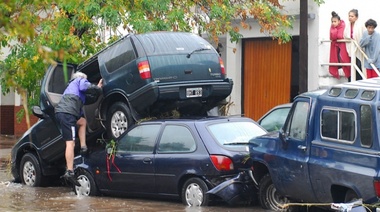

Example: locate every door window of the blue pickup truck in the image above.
[287,102,309,140]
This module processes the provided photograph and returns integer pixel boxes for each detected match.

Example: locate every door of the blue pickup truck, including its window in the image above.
[274,98,313,202]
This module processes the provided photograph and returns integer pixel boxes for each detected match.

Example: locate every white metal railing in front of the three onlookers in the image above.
[321,39,380,81]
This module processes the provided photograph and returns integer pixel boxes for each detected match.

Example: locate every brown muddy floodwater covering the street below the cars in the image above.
[0,145,263,212]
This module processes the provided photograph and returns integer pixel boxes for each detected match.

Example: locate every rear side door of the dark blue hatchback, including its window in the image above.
[155,124,200,195]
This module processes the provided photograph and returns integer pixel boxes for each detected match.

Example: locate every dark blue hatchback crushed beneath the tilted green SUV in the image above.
[75,117,266,206]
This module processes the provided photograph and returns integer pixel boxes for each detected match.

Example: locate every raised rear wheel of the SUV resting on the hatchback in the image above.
[107,102,132,139]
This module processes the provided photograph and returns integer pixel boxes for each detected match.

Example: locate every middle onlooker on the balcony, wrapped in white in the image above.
[344,9,366,81]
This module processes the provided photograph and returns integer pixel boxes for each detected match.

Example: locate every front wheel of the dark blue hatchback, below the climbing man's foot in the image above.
[74,169,98,196]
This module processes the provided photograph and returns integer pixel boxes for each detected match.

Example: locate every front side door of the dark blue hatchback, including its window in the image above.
[104,124,161,193]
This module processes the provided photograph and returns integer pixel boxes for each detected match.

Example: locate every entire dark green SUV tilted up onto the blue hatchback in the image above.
[11,32,233,186]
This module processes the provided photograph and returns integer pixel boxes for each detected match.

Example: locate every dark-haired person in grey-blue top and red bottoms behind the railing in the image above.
[360,19,380,78]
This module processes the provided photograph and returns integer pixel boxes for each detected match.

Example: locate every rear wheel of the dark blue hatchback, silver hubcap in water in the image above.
[182,177,209,206]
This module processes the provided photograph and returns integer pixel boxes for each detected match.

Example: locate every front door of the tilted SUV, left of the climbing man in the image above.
[32,63,75,161]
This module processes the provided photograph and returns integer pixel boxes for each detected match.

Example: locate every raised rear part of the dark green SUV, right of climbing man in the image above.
[77,32,233,138]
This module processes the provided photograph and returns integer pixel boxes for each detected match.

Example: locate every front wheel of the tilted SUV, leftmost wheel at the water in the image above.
[20,153,42,187]
